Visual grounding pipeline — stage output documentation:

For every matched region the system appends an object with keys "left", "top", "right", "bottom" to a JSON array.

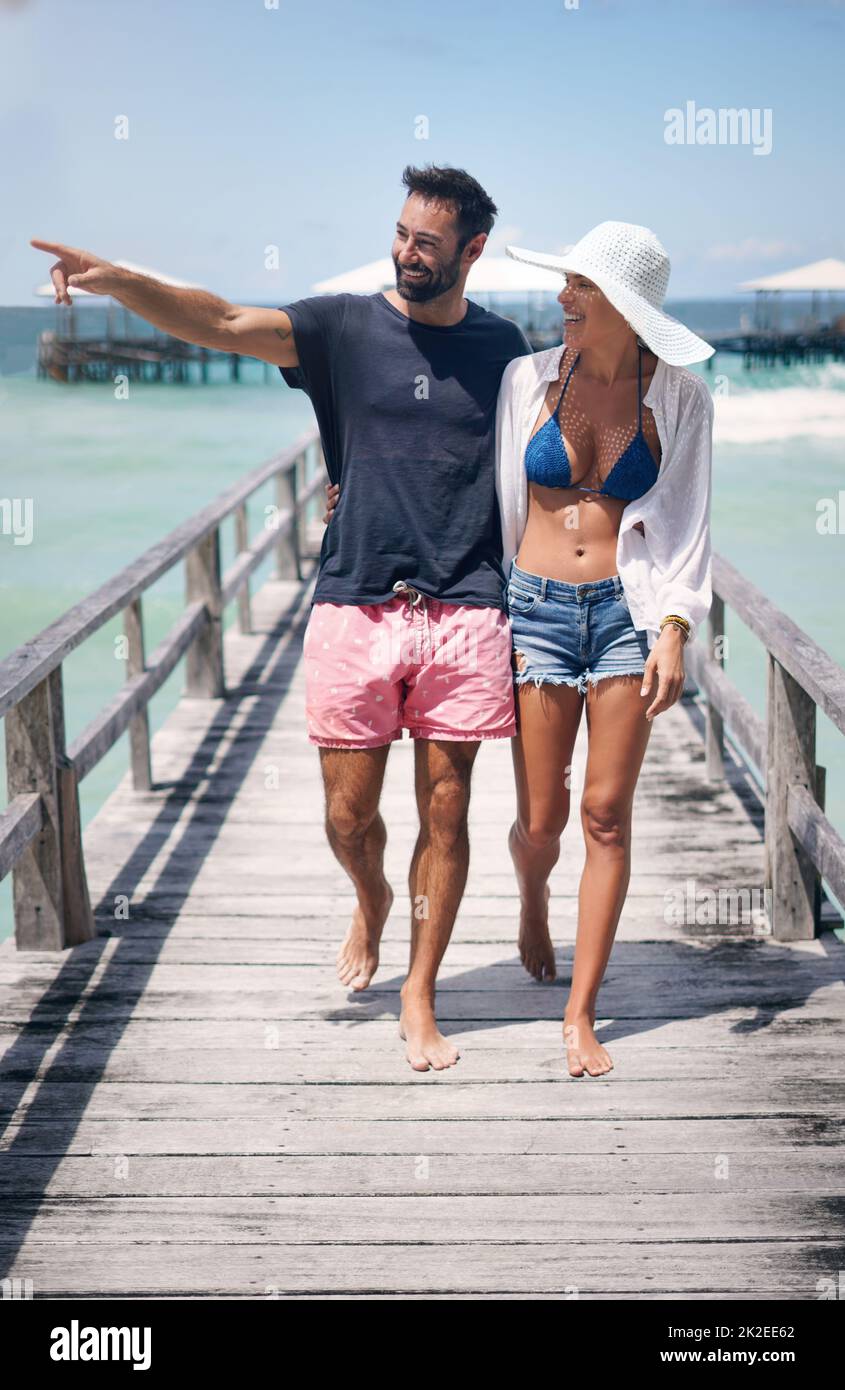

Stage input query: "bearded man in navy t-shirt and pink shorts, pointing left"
[{"left": 32, "top": 167, "right": 531, "bottom": 1072}]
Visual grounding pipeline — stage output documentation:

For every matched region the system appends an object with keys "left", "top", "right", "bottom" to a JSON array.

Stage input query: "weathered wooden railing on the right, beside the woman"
[{"left": 685, "top": 555, "right": 845, "bottom": 941}]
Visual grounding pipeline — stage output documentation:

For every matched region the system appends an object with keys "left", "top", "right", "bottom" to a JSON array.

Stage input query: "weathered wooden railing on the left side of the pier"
[{"left": 0, "top": 431, "right": 325, "bottom": 951}]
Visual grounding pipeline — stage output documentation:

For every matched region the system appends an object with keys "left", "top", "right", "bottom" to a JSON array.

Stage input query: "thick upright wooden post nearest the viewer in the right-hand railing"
[{"left": 764, "top": 653, "right": 817, "bottom": 941}]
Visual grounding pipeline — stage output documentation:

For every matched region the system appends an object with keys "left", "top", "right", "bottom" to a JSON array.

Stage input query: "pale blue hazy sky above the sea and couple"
[{"left": 0, "top": 0, "right": 845, "bottom": 304}]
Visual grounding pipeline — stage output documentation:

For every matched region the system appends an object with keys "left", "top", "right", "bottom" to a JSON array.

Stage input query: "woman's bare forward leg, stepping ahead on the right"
[{"left": 563, "top": 676, "right": 652, "bottom": 1076}]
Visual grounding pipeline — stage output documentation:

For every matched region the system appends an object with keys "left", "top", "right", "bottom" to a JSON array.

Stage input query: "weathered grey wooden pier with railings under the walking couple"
[{"left": 0, "top": 442, "right": 845, "bottom": 1300}]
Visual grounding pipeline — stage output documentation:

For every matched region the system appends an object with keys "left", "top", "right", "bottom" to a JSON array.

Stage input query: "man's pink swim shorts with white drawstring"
[{"left": 303, "top": 588, "right": 516, "bottom": 748}]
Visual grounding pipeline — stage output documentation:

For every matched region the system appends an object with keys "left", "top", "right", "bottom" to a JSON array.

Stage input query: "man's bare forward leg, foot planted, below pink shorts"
[{"left": 399, "top": 738, "right": 478, "bottom": 1072}]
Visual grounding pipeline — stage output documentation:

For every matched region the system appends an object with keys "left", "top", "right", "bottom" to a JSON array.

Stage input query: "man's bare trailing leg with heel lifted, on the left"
[{"left": 320, "top": 744, "right": 393, "bottom": 990}]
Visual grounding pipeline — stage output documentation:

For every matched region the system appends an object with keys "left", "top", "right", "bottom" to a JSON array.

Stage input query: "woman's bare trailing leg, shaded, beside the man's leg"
[{"left": 507, "top": 682, "right": 584, "bottom": 980}]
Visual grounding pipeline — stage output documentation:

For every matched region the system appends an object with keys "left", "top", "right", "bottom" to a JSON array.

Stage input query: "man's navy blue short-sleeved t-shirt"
[{"left": 279, "top": 293, "right": 531, "bottom": 609}]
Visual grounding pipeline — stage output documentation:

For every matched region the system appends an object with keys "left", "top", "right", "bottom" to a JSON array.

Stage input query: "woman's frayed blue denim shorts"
[{"left": 507, "top": 562, "right": 649, "bottom": 694}]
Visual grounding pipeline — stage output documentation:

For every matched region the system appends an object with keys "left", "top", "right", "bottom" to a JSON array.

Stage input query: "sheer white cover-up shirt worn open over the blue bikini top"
[{"left": 496, "top": 346, "right": 713, "bottom": 648}]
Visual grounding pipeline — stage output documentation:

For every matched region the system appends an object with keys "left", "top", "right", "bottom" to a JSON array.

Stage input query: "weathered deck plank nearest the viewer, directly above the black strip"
[{"left": 0, "top": 1240, "right": 845, "bottom": 1300}]
